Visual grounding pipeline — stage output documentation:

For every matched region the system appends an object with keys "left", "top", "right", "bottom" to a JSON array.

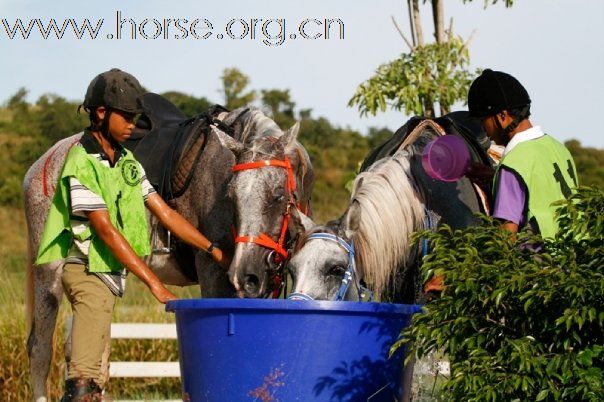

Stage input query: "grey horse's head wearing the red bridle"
[{"left": 217, "top": 110, "right": 313, "bottom": 297}]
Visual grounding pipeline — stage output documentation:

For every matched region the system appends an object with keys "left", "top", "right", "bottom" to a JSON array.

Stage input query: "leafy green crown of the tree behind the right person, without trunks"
[{"left": 348, "top": 35, "right": 473, "bottom": 116}]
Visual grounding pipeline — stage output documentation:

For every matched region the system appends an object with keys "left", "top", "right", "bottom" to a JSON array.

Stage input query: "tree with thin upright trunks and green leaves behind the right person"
[{"left": 348, "top": 0, "right": 513, "bottom": 117}]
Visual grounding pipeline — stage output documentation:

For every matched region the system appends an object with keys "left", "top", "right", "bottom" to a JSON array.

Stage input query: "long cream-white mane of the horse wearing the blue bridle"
[{"left": 349, "top": 149, "right": 425, "bottom": 295}]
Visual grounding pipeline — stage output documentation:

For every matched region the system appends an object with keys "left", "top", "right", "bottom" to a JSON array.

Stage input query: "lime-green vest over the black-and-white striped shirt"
[{"left": 36, "top": 145, "right": 151, "bottom": 272}]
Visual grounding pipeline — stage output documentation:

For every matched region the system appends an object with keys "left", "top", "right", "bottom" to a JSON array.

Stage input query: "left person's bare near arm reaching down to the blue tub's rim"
[{"left": 85, "top": 209, "right": 176, "bottom": 303}]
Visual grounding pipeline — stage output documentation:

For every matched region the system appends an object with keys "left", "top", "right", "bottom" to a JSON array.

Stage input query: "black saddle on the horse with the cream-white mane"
[{"left": 361, "top": 111, "right": 491, "bottom": 172}]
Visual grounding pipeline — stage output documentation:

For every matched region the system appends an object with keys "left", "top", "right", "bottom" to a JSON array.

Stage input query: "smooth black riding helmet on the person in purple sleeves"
[{"left": 468, "top": 69, "right": 531, "bottom": 117}]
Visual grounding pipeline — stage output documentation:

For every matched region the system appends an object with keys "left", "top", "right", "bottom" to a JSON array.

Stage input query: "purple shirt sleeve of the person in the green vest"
[{"left": 493, "top": 169, "right": 526, "bottom": 226}]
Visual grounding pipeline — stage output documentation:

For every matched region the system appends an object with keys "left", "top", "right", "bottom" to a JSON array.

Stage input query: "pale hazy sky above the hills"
[{"left": 0, "top": 0, "right": 604, "bottom": 148}]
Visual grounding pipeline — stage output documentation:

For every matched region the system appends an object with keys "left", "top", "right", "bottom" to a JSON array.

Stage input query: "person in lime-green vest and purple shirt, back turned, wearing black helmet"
[{"left": 467, "top": 69, "right": 578, "bottom": 238}]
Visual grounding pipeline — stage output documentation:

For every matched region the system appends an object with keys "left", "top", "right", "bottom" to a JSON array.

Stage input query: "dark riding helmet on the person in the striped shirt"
[{"left": 82, "top": 68, "right": 145, "bottom": 113}]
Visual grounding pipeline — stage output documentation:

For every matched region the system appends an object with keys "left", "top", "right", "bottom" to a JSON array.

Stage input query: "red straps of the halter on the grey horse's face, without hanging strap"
[{"left": 233, "top": 156, "right": 296, "bottom": 263}]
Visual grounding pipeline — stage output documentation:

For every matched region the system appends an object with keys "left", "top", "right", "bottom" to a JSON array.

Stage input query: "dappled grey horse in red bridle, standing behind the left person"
[{"left": 23, "top": 108, "right": 313, "bottom": 402}]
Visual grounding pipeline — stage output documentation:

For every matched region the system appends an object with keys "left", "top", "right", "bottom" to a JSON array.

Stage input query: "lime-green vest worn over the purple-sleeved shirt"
[{"left": 493, "top": 135, "right": 578, "bottom": 238}]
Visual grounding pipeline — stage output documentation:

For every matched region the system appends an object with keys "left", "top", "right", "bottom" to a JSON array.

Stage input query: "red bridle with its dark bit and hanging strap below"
[{"left": 232, "top": 156, "right": 297, "bottom": 297}]
